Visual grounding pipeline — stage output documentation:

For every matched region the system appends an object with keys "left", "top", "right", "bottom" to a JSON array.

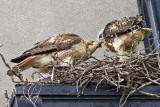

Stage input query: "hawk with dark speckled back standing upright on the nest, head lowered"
[{"left": 98, "top": 15, "right": 151, "bottom": 62}]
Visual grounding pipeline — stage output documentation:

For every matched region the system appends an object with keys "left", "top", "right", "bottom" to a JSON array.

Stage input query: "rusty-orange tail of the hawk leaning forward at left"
[{"left": 7, "top": 56, "right": 35, "bottom": 77}]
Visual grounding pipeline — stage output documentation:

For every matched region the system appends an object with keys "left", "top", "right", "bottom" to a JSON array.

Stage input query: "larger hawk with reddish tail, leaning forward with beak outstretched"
[{"left": 7, "top": 34, "right": 101, "bottom": 76}]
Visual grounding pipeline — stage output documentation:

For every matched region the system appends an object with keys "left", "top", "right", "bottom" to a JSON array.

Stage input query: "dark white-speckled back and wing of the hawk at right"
[{"left": 103, "top": 15, "right": 144, "bottom": 39}]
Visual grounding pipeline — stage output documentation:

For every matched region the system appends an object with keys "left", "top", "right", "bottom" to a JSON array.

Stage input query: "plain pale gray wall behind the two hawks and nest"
[{"left": 0, "top": 0, "right": 140, "bottom": 107}]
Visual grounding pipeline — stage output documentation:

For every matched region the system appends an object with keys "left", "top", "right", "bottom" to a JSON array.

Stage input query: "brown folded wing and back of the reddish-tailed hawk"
[{"left": 11, "top": 34, "right": 82, "bottom": 63}]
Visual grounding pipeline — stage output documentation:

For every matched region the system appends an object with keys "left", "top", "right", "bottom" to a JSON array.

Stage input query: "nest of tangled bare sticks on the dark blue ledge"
[{"left": 39, "top": 53, "right": 160, "bottom": 89}]
